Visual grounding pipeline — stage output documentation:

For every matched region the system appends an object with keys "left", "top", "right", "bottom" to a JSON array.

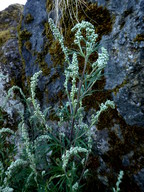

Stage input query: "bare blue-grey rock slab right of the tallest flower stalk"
[{"left": 97, "top": 0, "right": 144, "bottom": 127}]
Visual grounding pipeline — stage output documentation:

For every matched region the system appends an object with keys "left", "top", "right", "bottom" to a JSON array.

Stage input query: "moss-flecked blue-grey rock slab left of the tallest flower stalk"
[{"left": 20, "top": 0, "right": 64, "bottom": 110}]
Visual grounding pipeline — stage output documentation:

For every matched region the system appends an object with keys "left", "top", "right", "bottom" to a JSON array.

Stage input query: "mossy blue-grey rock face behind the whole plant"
[{"left": 0, "top": 0, "right": 144, "bottom": 192}]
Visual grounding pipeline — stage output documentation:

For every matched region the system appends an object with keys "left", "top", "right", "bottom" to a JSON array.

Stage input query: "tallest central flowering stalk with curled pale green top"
[{"left": 49, "top": 19, "right": 115, "bottom": 191}]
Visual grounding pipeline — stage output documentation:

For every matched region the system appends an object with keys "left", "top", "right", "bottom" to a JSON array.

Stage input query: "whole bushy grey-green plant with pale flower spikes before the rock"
[{"left": 0, "top": 19, "right": 115, "bottom": 192}]
